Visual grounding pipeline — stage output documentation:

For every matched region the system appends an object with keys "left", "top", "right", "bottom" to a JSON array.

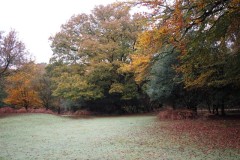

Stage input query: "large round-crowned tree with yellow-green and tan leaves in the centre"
[{"left": 50, "top": 3, "right": 144, "bottom": 110}]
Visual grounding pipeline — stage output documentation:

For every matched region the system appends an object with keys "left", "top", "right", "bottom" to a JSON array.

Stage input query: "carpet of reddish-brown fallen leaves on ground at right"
[{"left": 162, "top": 120, "right": 240, "bottom": 151}]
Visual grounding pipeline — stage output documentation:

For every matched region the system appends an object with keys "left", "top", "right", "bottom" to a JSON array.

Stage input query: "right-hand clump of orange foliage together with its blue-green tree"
[{"left": 125, "top": 0, "right": 240, "bottom": 115}]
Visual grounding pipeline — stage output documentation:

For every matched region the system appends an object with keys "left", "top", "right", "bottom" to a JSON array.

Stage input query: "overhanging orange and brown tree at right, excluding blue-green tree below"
[{"left": 129, "top": 0, "right": 240, "bottom": 114}]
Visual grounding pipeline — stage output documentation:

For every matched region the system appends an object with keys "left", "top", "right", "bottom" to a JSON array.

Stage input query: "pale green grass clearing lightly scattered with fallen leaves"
[{"left": 0, "top": 114, "right": 240, "bottom": 160}]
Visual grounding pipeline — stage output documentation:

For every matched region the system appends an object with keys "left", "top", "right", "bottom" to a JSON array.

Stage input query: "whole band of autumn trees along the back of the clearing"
[{"left": 0, "top": 0, "right": 240, "bottom": 115}]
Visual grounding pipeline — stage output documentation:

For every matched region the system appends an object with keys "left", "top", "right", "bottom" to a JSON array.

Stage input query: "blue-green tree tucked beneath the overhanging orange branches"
[{"left": 146, "top": 47, "right": 180, "bottom": 107}]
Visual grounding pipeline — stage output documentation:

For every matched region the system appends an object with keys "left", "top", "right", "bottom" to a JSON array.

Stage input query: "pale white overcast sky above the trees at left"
[{"left": 0, "top": 0, "right": 122, "bottom": 63}]
